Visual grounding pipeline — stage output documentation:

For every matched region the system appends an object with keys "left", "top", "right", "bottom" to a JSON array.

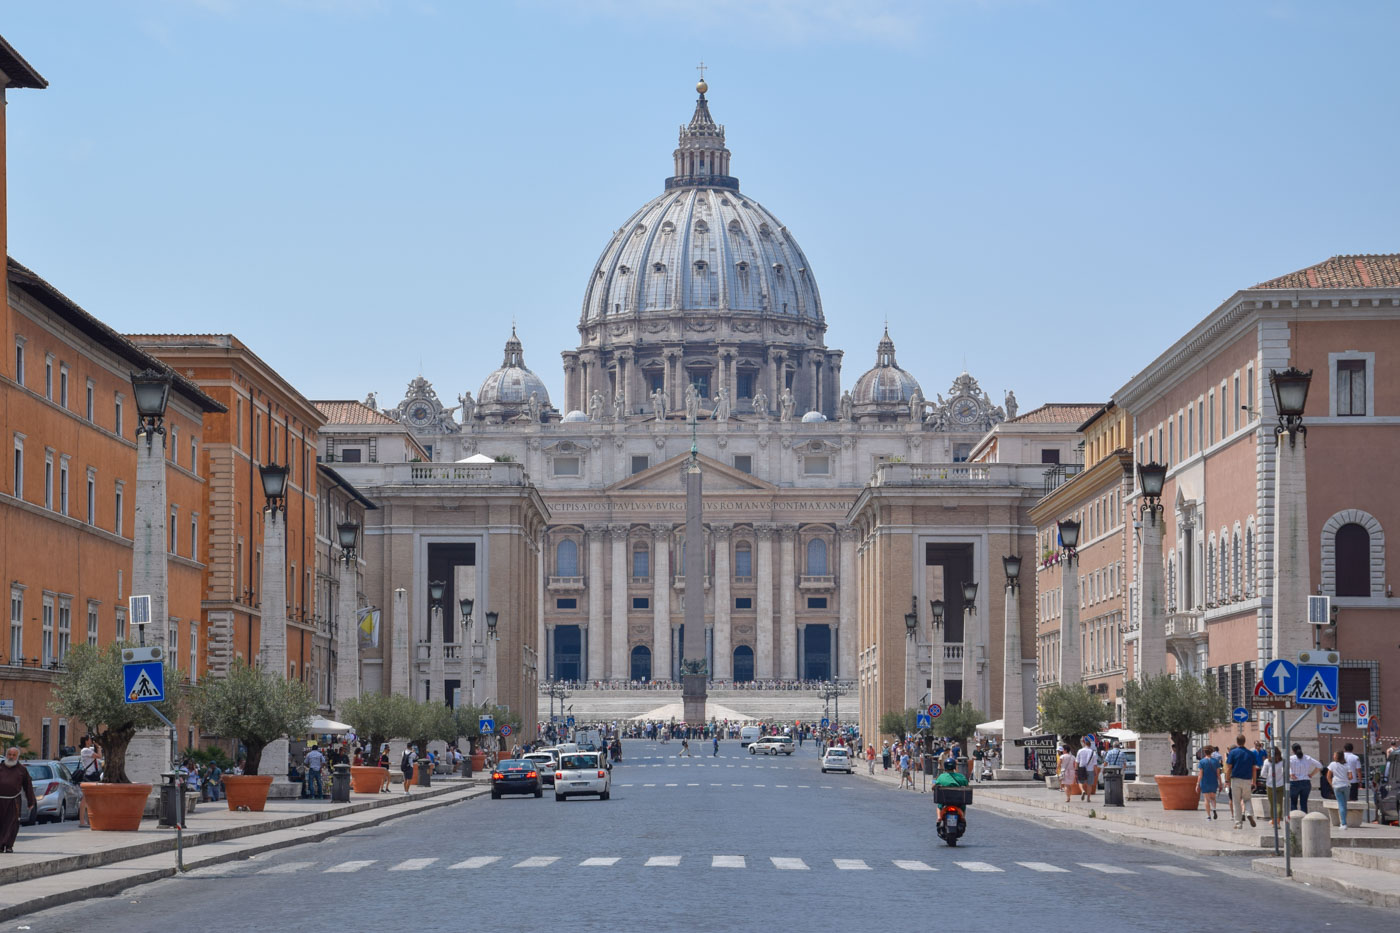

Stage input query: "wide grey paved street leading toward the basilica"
[{"left": 21, "top": 740, "right": 1389, "bottom": 933}]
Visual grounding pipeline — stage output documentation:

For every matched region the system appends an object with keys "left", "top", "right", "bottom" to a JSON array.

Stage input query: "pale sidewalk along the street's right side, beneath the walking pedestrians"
[{"left": 855, "top": 758, "right": 1400, "bottom": 906}]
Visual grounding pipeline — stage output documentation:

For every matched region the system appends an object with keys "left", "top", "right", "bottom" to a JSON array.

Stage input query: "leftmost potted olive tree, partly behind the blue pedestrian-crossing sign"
[{"left": 52, "top": 642, "right": 181, "bottom": 831}]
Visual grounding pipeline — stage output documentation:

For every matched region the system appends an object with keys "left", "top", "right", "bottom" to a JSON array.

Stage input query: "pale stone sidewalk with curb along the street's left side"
[{"left": 0, "top": 778, "right": 490, "bottom": 920}]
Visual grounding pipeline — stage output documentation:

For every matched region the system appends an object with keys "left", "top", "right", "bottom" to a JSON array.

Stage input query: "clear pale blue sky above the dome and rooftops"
[{"left": 0, "top": 0, "right": 1400, "bottom": 410}]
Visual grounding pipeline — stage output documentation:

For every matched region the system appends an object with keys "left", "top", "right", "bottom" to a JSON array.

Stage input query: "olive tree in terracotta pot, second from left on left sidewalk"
[{"left": 192, "top": 661, "right": 316, "bottom": 811}]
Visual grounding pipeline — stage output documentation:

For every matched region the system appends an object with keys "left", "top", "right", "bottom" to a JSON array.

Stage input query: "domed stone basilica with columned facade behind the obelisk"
[{"left": 340, "top": 83, "right": 1016, "bottom": 681}]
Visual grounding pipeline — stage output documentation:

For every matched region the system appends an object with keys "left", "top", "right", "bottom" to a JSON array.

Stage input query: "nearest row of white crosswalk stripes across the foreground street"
[{"left": 221, "top": 850, "right": 1204, "bottom": 878}]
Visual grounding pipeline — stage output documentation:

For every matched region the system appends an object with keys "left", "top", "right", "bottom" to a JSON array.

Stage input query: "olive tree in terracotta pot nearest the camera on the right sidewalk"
[{"left": 1123, "top": 674, "right": 1231, "bottom": 810}]
